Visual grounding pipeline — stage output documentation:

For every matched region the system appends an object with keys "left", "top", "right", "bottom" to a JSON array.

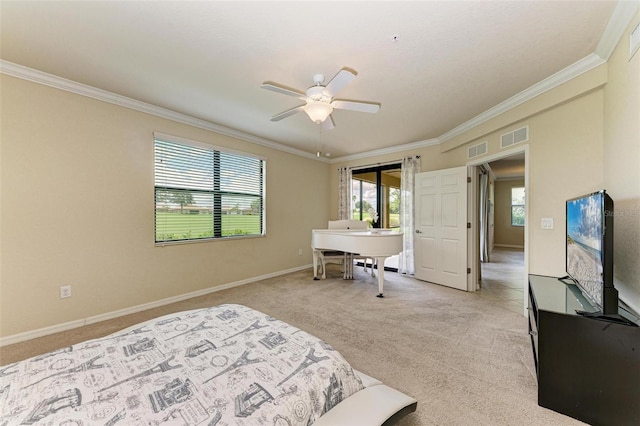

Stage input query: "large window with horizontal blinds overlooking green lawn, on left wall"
[{"left": 155, "top": 134, "right": 266, "bottom": 243}]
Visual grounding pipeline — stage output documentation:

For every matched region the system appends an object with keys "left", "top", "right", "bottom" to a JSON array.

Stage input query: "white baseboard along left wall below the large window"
[{"left": 0, "top": 265, "right": 312, "bottom": 347}]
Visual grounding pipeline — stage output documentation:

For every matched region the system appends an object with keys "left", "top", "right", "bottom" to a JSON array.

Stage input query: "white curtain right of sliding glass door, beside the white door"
[{"left": 398, "top": 156, "right": 420, "bottom": 275}]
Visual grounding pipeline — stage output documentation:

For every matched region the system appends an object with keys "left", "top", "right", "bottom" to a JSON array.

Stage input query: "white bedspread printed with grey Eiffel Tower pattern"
[{"left": 0, "top": 305, "right": 362, "bottom": 426}]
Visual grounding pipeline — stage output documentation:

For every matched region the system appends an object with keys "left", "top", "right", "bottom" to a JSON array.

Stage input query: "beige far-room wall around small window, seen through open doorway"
[{"left": 493, "top": 179, "right": 524, "bottom": 247}]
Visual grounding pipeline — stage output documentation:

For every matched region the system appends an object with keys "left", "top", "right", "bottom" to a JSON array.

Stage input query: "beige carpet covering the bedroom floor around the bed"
[{"left": 0, "top": 265, "right": 582, "bottom": 426}]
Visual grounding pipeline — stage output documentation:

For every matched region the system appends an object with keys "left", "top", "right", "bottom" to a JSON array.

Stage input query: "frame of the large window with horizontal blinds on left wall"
[{"left": 153, "top": 132, "right": 267, "bottom": 246}]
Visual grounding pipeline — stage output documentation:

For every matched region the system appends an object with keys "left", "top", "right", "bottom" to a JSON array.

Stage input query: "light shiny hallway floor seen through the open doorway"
[{"left": 478, "top": 247, "right": 525, "bottom": 314}]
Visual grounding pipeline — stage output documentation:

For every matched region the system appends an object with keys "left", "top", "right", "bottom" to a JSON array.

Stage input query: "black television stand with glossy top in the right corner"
[{"left": 528, "top": 275, "right": 640, "bottom": 425}]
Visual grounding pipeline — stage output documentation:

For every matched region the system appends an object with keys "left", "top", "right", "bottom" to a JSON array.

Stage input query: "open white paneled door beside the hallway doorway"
[{"left": 414, "top": 166, "right": 468, "bottom": 290}]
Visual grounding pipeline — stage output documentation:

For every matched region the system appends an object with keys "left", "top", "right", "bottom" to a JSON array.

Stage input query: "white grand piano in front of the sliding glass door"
[{"left": 311, "top": 229, "right": 402, "bottom": 297}]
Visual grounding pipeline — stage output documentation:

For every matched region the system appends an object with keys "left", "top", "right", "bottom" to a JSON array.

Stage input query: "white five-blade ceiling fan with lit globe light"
[{"left": 260, "top": 67, "right": 380, "bottom": 130}]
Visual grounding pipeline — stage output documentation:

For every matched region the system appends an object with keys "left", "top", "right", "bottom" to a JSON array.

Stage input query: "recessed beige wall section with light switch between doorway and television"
[{"left": 516, "top": 90, "right": 603, "bottom": 276}]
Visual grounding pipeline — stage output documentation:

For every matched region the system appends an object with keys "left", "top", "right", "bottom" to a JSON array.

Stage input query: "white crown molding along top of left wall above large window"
[{"left": 0, "top": 60, "right": 320, "bottom": 162}]
